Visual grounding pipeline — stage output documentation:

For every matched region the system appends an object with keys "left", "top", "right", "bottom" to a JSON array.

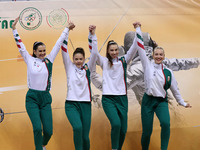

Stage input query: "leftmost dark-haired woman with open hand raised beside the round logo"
[{"left": 12, "top": 17, "right": 74, "bottom": 150}]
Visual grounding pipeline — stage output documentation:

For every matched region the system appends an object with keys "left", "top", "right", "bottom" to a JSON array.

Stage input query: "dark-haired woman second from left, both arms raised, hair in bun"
[{"left": 61, "top": 25, "right": 98, "bottom": 150}]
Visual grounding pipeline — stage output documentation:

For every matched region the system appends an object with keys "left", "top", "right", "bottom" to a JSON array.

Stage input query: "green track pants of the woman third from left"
[{"left": 102, "top": 95, "right": 128, "bottom": 150}]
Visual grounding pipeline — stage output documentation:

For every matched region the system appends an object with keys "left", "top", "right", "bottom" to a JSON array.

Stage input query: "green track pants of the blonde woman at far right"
[{"left": 141, "top": 94, "right": 170, "bottom": 150}]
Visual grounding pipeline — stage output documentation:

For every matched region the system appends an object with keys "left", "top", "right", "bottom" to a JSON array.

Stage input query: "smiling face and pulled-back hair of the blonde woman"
[{"left": 153, "top": 47, "right": 165, "bottom": 64}]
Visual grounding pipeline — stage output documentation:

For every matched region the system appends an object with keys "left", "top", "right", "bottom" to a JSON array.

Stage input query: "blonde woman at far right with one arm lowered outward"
[{"left": 134, "top": 23, "right": 191, "bottom": 150}]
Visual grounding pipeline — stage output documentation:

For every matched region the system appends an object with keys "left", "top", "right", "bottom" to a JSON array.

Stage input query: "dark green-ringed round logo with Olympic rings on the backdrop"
[{"left": 19, "top": 7, "right": 42, "bottom": 30}]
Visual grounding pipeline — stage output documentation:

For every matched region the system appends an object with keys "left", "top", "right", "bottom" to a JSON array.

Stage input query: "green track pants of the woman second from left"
[{"left": 65, "top": 101, "right": 91, "bottom": 150}]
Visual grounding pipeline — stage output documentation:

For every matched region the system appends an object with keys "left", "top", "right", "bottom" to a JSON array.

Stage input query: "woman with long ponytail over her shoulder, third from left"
[{"left": 92, "top": 22, "right": 137, "bottom": 150}]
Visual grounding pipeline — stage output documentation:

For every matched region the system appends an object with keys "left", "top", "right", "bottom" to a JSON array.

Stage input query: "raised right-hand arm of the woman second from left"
[{"left": 88, "top": 25, "right": 98, "bottom": 71}]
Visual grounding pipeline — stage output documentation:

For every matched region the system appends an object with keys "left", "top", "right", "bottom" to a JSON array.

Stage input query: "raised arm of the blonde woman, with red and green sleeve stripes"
[{"left": 133, "top": 22, "right": 150, "bottom": 70}]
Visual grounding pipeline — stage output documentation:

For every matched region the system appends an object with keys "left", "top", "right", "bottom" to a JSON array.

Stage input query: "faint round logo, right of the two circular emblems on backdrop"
[{"left": 46, "top": 8, "right": 69, "bottom": 29}]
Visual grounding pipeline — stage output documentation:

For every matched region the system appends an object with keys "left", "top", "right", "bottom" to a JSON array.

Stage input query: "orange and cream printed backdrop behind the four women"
[{"left": 0, "top": 0, "right": 200, "bottom": 150}]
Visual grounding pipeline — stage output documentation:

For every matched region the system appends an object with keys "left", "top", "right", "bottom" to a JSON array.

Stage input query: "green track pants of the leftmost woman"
[{"left": 26, "top": 89, "right": 53, "bottom": 150}]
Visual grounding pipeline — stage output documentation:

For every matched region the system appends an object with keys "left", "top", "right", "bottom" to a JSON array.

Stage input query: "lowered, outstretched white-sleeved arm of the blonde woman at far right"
[{"left": 170, "top": 71, "right": 191, "bottom": 108}]
